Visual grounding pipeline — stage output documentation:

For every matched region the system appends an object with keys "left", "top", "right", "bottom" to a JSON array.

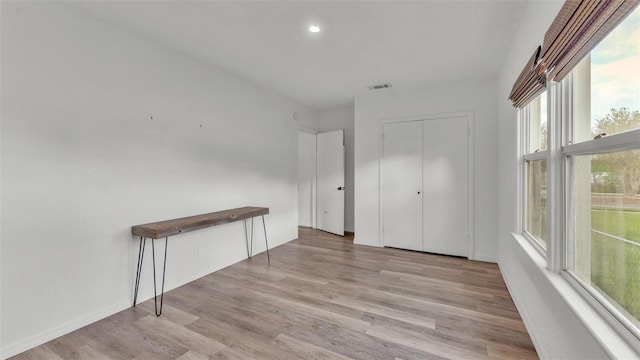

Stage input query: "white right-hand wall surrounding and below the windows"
[{"left": 497, "top": 1, "right": 637, "bottom": 359}]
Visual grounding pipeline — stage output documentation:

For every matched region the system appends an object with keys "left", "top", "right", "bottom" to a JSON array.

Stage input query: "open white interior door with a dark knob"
[{"left": 316, "top": 130, "right": 344, "bottom": 235}]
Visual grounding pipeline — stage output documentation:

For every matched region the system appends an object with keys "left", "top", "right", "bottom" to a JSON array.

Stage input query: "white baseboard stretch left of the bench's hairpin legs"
[{"left": 0, "top": 300, "right": 131, "bottom": 359}]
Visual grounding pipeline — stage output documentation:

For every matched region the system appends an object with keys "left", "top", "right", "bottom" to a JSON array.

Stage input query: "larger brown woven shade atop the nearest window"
[{"left": 540, "top": 0, "right": 640, "bottom": 81}]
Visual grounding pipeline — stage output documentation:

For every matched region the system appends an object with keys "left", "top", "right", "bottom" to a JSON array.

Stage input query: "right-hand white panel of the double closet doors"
[{"left": 422, "top": 116, "right": 469, "bottom": 257}]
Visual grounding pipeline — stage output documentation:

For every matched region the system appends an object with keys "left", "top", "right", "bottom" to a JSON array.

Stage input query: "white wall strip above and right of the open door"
[{"left": 318, "top": 106, "right": 354, "bottom": 231}]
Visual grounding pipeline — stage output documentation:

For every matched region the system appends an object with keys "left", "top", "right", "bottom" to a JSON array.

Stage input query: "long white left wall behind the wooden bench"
[{"left": 0, "top": 2, "right": 317, "bottom": 356}]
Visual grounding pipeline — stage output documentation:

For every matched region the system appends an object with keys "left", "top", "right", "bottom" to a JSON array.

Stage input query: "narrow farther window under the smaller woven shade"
[{"left": 523, "top": 91, "right": 547, "bottom": 250}]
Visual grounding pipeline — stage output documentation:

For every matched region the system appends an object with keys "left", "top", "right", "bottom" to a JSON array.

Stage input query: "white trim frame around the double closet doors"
[{"left": 378, "top": 111, "right": 476, "bottom": 260}]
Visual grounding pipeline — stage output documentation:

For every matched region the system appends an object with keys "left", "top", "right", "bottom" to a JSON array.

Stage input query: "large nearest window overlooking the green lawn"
[{"left": 563, "top": 8, "right": 640, "bottom": 333}]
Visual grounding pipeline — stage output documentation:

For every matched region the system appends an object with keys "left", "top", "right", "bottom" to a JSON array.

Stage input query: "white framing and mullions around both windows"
[{"left": 517, "top": 63, "right": 640, "bottom": 352}]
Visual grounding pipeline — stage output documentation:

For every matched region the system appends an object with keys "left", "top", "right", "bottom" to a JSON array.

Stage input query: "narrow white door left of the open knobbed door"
[{"left": 298, "top": 131, "right": 316, "bottom": 227}]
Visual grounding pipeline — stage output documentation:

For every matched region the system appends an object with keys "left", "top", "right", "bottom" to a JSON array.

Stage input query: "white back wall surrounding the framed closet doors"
[{"left": 354, "top": 79, "right": 498, "bottom": 261}]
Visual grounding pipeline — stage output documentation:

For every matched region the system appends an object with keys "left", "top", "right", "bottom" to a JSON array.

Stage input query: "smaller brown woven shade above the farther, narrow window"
[{"left": 509, "top": 46, "right": 547, "bottom": 107}]
